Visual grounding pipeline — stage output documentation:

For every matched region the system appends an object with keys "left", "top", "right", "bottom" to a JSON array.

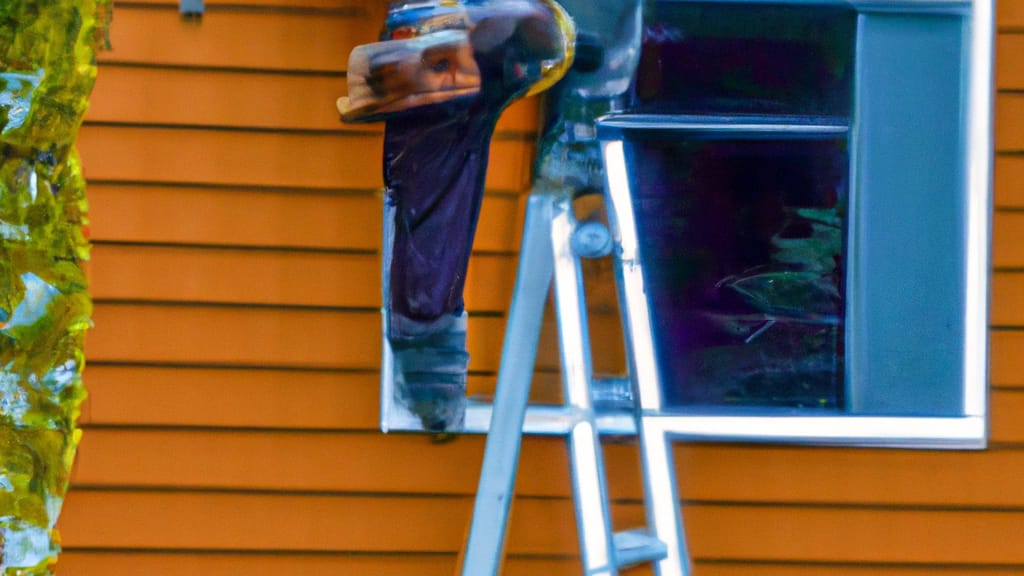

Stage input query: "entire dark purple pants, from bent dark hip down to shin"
[{"left": 384, "top": 11, "right": 559, "bottom": 341}]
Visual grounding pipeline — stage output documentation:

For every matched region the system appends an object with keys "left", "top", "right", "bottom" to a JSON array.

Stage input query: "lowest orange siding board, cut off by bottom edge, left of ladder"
[{"left": 57, "top": 549, "right": 585, "bottom": 576}]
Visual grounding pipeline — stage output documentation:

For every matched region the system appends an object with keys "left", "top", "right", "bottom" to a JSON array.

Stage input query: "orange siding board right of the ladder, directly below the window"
[{"left": 676, "top": 445, "right": 1024, "bottom": 508}]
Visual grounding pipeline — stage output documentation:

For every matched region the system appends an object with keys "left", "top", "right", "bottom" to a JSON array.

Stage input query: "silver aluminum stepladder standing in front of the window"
[{"left": 459, "top": 192, "right": 690, "bottom": 576}]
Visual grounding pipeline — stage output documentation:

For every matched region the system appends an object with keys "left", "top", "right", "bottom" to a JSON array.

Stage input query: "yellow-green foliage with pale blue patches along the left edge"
[{"left": 0, "top": 0, "right": 111, "bottom": 576}]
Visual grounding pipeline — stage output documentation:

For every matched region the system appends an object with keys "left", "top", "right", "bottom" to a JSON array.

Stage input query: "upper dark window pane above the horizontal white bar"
[{"left": 636, "top": 0, "right": 856, "bottom": 117}]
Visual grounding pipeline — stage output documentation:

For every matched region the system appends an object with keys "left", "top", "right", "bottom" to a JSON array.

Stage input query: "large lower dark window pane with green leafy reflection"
[{"left": 627, "top": 138, "right": 848, "bottom": 409}]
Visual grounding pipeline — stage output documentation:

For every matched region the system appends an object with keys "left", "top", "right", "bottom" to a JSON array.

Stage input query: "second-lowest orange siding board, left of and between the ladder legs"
[{"left": 58, "top": 485, "right": 593, "bottom": 554}]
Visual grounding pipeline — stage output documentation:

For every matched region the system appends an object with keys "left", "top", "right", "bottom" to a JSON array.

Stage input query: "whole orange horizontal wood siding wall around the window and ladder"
[{"left": 58, "top": 0, "right": 1024, "bottom": 576}]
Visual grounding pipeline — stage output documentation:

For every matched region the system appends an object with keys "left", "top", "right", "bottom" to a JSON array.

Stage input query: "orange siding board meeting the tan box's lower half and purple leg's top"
[{"left": 86, "top": 64, "right": 538, "bottom": 132}]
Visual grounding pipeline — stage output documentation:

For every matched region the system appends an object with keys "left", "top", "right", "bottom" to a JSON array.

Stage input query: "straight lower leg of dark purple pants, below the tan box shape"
[{"left": 384, "top": 101, "right": 497, "bottom": 340}]
